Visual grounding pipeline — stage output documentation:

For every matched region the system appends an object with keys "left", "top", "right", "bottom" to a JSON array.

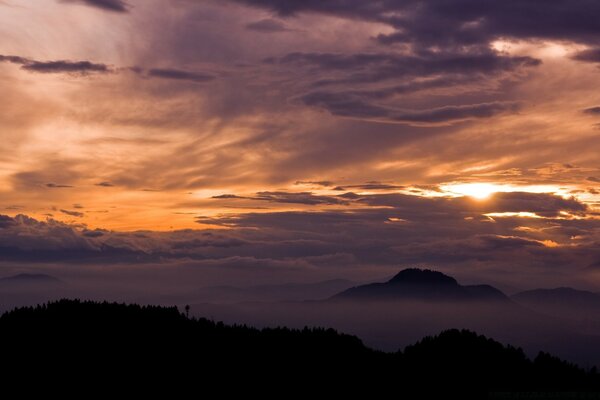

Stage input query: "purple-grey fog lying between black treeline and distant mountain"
[{"left": 0, "top": 275, "right": 600, "bottom": 367}]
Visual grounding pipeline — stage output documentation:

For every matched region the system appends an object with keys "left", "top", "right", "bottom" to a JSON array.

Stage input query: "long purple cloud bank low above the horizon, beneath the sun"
[{"left": 0, "top": 183, "right": 600, "bottom": 290}]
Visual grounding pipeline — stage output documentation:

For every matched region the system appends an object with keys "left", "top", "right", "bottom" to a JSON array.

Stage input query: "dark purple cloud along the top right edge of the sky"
[{"left": 232, "top": 0, "right": 600, "bottom": 48}]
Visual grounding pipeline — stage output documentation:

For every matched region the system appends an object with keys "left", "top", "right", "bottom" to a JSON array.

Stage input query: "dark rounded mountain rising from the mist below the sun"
[{"left": 332, "top": 268, "right": 509, "bottom": 301}]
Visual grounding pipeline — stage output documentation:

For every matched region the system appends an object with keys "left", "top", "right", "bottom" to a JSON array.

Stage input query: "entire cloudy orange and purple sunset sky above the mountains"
[{"left": 0, "top": 0, "right": 600, "bottom": 290}]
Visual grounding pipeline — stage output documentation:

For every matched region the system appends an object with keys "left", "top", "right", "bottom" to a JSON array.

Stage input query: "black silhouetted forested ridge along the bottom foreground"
[{"left": 0, "top": 300, "right": 600, "bottom": 398}]
